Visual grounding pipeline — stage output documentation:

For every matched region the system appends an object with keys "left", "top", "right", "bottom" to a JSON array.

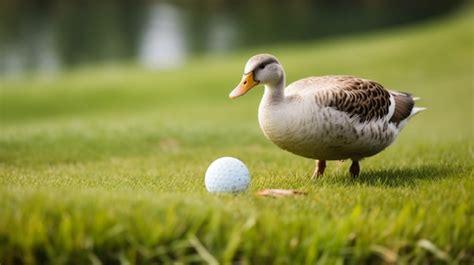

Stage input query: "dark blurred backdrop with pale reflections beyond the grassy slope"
[{"left": 0, "top": 0, "right": 462, "bottom": 79}]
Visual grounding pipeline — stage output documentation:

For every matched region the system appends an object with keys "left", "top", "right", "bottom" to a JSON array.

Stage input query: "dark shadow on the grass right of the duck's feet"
[{"left": 352, "top": 165, "right": 463, "bottom": 187}]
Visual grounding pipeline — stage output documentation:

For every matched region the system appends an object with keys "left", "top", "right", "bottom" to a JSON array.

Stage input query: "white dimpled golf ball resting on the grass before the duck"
[{"left": 204, "top": 157, "right": 250, "bottom": 193}]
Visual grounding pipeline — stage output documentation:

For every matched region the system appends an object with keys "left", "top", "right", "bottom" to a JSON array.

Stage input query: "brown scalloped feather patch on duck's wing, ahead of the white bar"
[{"left": 328, "top": 76, "right": 390, "bottom": 122}]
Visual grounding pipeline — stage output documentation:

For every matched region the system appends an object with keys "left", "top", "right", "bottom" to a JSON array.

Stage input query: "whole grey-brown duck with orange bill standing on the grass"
[{"left": 229, "top": 54, "right": 426, "bottom": 178}]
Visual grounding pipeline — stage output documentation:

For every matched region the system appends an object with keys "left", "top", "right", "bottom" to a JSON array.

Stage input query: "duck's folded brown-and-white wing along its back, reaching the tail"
[{"left": 292, "top": 76, "right": 423, "bottom": 125}]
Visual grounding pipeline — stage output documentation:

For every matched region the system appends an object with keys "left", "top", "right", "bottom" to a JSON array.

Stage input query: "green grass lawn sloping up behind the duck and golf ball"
[{"left": 0, "top": 8, "right": 474, "bottom": 264}]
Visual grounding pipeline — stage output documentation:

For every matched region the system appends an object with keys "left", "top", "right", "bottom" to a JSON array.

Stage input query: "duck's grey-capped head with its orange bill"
[{"left": 229, "top": 54, "right": 284, "bottom": 98}]
